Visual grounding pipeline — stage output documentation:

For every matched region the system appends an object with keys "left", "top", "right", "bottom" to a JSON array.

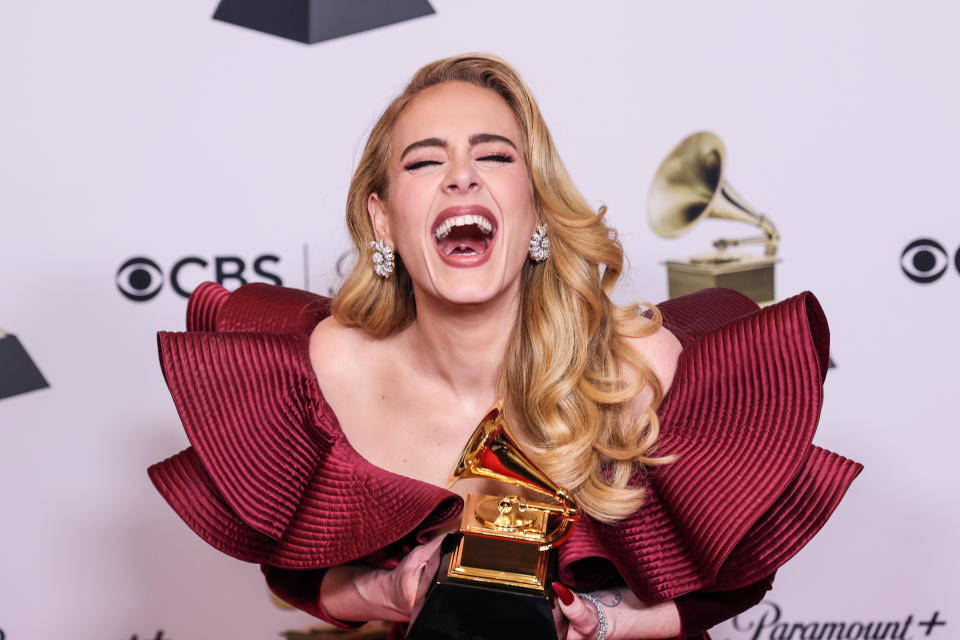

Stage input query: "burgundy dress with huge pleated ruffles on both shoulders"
[{"left": 149, "top": 283, "right": 862, "bottom": 638}]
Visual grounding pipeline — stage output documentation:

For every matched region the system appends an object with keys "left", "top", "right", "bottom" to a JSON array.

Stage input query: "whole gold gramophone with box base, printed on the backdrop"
[{"left": 647, "top": 131, "right": 780, "bottom": 305}]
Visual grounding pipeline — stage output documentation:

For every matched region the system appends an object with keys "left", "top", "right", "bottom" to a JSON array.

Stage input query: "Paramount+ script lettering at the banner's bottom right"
[{"left": 725, "top": 600, "right": 947, "bottom": 640}]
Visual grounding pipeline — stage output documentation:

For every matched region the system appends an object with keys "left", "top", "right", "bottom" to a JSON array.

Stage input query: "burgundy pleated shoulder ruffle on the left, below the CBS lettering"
[{"left": 149, "top": 285, "right": 462, "bottom": 569}]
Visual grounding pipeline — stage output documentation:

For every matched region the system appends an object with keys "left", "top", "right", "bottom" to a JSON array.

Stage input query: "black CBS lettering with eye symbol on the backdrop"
[{"left": 116, "top": 253, "right": 283, "bottom": 302}]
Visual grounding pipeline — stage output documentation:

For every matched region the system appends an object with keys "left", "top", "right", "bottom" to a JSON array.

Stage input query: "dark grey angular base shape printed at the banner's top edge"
[{"left": 213, "top": 0, "right": 436, "bottom": 44}]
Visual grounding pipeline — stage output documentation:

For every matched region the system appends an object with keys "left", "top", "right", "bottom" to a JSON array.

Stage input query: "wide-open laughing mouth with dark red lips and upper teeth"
[{"left": 433, "top": 206, "right": 497, "bottom": 267}]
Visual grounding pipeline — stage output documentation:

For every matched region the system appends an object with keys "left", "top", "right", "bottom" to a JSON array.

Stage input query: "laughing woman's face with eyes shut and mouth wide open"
[{"left": 368, "top": 82, "right": 537, "bottom": 304}]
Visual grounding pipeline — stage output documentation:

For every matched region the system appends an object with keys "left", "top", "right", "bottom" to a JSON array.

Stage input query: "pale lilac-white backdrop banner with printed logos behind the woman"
[{"left": 0, "top": 0, "right": 960, "bottom": 640}]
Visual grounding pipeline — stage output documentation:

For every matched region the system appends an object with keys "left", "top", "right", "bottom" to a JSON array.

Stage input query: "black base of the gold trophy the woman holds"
[{"left": 407, "top": 535, "right": 557, "bottom": 640}]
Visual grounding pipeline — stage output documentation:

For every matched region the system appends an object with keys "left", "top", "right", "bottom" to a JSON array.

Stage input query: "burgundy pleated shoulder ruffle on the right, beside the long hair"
[{"left": 560, "top": 290, "right": 861, "bottom": 602}]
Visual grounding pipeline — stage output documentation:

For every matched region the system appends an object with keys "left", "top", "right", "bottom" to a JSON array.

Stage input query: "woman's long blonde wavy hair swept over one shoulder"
[{"left": 332, "top": 54, "right": 669, "bottom": 522}]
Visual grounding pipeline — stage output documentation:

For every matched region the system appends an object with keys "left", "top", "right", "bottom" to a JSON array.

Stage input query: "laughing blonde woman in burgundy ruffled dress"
[{"left": 151, "top": 55, "right": 859, "bottom": 639}]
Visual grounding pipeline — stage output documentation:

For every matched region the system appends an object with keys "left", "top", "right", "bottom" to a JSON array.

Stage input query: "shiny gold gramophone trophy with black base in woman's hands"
[{"left": 407, "top": 409, "right": 579, "bottom": 640}]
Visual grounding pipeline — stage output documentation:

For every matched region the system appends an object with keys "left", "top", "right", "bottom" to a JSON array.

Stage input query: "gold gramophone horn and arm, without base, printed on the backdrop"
[{"left": 647, "top": 131, "right": 780, "bottom": 256}]
